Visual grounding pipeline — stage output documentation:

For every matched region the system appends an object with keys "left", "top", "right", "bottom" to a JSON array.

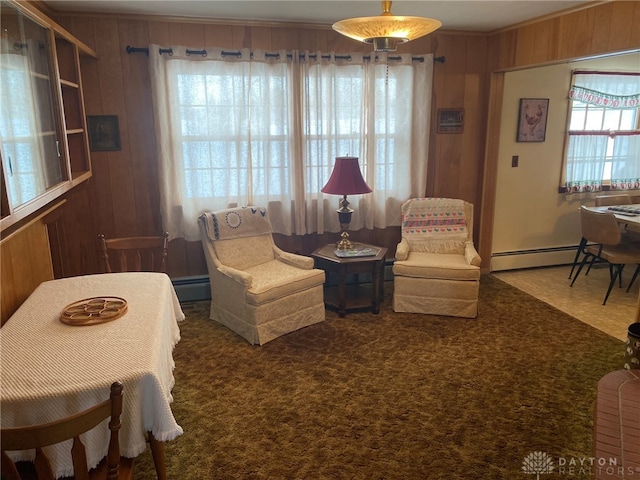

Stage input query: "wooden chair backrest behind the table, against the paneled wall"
[{"left": 98, "top": 232, "right": 169, "bottom": 273}]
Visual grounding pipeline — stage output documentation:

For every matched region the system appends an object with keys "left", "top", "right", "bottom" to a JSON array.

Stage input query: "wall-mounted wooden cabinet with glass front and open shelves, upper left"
[{"left": 0, "top": 0, "right": 97, "bottom": 235}]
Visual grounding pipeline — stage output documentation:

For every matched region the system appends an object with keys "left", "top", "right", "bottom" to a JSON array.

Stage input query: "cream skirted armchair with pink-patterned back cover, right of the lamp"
[{"left": 393, "top": 198, "right": 480, "bottom": 318}]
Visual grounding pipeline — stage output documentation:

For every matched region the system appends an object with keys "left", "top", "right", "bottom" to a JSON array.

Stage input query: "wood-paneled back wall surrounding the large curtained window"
[{"left": 46, "top": 12, "right": 487, "bottom": 277}]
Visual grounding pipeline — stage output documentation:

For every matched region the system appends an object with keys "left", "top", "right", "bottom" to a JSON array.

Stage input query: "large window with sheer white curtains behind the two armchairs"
[{"left": 150, "top": 45, "right": 433, "bottom": 240}]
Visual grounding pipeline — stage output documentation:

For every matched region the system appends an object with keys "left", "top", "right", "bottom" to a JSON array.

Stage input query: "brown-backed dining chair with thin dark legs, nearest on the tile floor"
[{"left": 571, "top": 205, "right": 640, "bottom": 305}]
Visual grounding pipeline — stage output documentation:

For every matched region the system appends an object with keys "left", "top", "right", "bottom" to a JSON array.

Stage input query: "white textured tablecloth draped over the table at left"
[{"left": 0, "top": 273, "right": 184, "bottom": 477}]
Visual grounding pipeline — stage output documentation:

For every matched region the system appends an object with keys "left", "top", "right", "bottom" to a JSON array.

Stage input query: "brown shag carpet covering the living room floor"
[{"left": 135, "top": 276, "right": 624, "bottom": 480}]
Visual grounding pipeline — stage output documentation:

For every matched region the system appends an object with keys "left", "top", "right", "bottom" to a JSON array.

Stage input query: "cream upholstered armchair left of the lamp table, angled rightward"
[{"left": 198, "top": 207, "right": 325, "bottom": 345}]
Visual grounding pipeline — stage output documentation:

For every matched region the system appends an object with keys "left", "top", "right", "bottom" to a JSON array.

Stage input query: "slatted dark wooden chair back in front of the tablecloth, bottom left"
[{"left": 0, "top": 382, "right": 123, "bottom": 480}]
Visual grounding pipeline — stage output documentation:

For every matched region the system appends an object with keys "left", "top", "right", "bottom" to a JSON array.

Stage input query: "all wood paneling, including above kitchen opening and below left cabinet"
[{"left": 2, "top": 1, "right": 640, "bottom": 319}]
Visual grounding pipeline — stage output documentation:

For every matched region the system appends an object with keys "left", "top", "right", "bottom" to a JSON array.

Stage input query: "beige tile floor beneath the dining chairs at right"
[{"left": 492, "top": 265, "right": 640, "bottom": 341}]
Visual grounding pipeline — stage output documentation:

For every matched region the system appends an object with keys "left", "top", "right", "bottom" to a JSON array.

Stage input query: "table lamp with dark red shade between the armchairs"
[{"left": 320, "top": 157, "right": 371, "bottom": 250}]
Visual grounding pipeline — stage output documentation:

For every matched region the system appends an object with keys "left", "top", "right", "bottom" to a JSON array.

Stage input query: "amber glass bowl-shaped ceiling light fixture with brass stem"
[{"left": 333, "top": 1, "right": 442, "bottom": 52}]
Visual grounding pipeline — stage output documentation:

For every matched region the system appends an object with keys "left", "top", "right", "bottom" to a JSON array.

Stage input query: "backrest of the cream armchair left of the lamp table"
[{"left": 198, "top": 207, "right": 275, "bottom": 270}]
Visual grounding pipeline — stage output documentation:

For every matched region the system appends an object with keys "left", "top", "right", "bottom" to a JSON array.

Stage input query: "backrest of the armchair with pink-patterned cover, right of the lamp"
[{"left": 401, "top": 198, "right": 473, "bottom": 253}]
